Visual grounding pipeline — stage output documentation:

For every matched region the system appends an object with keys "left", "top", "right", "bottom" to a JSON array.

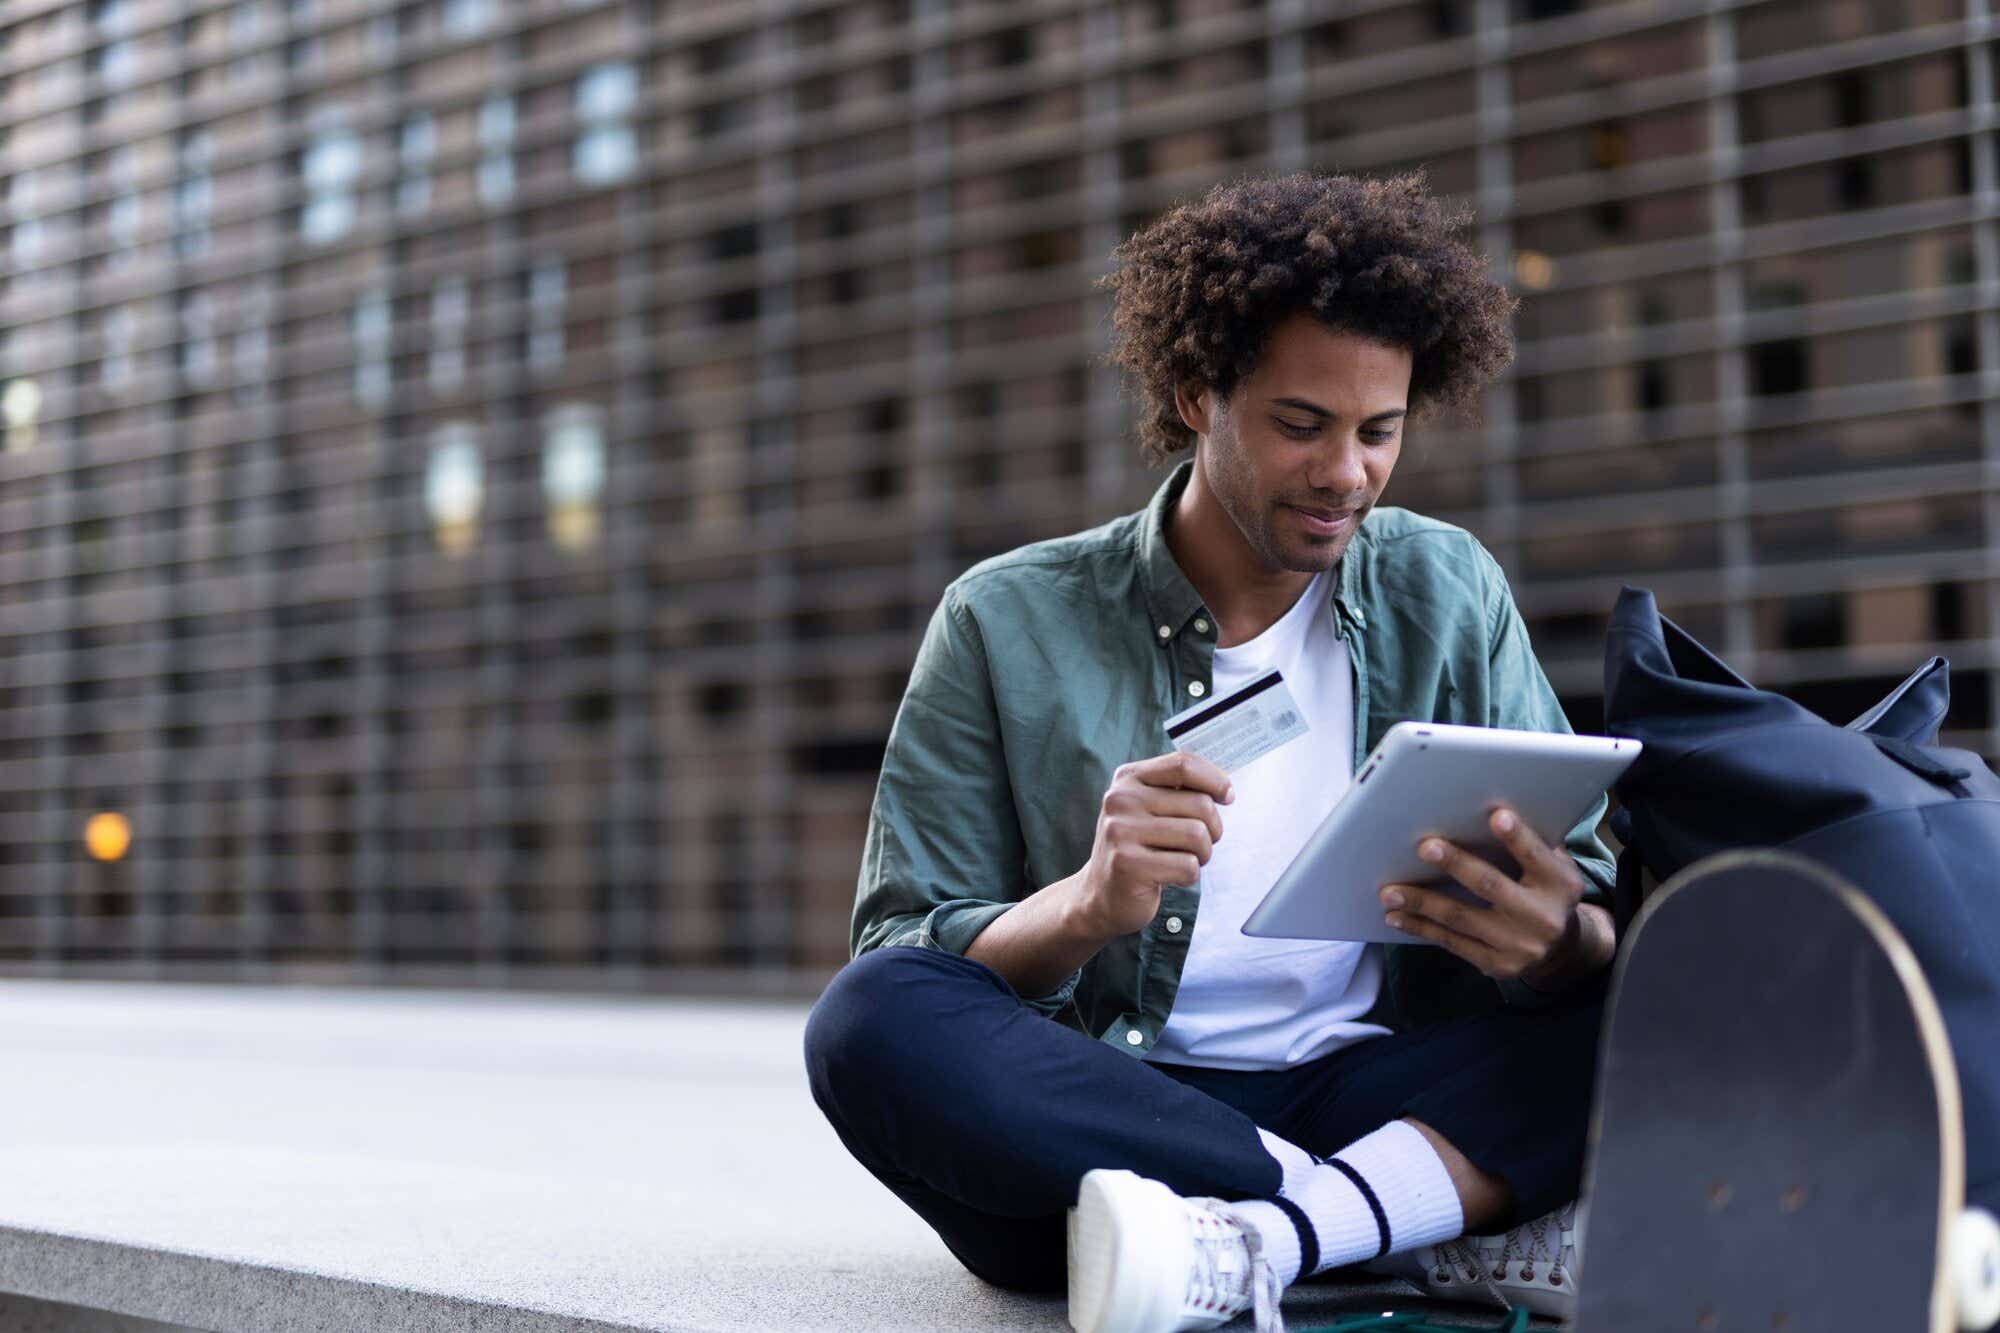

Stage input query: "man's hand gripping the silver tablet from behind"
[{"left": 1380, "top": 807, "right": 1614, "bottom": 989}]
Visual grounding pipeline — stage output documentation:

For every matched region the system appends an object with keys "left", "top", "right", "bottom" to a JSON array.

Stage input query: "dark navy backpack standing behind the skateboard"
[{"left": 1604, "top": 588, "right": 2000, "bottom": 1211}]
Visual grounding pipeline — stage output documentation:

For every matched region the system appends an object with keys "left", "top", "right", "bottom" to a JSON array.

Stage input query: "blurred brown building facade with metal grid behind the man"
[{"left": 0, "top": 0, "right": 2000, "bottom": 993}]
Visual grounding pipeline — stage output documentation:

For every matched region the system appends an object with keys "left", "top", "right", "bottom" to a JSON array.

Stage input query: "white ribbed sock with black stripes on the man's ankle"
[{"left": 1230, "top": 1121, "right": 1466, "bottom": 1285}]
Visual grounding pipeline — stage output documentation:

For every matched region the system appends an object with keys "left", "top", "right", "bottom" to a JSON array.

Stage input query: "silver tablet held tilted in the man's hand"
[{"left": 1244, "top": 723, "right": 1640, "bottom": 945}]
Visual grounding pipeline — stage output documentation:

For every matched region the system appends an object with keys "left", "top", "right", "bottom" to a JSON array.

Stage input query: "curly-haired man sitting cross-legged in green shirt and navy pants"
[{"left": 806, "top": 174, "right": 1614, "bottom": 1333}]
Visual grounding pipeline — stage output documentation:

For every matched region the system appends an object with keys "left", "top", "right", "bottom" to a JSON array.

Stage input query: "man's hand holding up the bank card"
[{"left": 1076, "top": 751, "right": 1234, "bottom": 939}]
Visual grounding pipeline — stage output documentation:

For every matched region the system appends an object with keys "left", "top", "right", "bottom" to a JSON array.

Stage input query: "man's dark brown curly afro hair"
[{"left": 1094, "top": 168, "right": 1520, "bottom": 464}]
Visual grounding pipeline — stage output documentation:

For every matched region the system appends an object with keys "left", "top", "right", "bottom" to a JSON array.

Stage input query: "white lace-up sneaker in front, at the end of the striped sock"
[{"left": 1070, "top": 1171, "right": 1284, "bottom": 1333}]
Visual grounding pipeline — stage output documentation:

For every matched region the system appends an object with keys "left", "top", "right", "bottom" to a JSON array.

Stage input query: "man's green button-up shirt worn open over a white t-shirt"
[{"left": 850, "top": 462, "right": 1614, "bottom": 1055}]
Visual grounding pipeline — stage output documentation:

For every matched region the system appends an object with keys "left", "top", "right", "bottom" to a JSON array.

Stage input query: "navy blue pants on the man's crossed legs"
[{"left": 806, "top": 947, "right": 1604, "bottom": 1291}]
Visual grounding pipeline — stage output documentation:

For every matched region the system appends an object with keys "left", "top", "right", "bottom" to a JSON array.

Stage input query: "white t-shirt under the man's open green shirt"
[{"left": 1148, "top": 572, "right": 1388, "bottom": 1069}]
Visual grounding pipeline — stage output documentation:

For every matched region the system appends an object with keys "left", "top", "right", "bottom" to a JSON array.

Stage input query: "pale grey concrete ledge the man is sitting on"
[{"left": 0, "top": 979, "right": 1536, "bottom": 1333}]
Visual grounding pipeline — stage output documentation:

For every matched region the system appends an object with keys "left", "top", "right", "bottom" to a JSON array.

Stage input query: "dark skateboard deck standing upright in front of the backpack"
[{"left": 1576, "top": 851, "right": 1964, "bottom": 1333}]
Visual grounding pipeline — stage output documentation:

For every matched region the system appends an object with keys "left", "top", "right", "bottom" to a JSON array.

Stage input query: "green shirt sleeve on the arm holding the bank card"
[{"left": 848, "top": 586, "right": 1082, "bottom": 1015}]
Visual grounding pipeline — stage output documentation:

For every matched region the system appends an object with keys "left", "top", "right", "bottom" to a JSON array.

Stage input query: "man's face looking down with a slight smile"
[{"left": 1180, "top": 314, "right": 1410, "bottom": 572}]
